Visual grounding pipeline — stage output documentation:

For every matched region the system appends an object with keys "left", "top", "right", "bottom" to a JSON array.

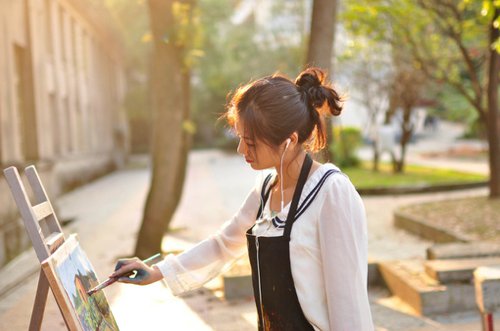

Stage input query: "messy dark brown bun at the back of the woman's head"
[{"left": 295, "top": 67, "right": 342, "bottom": 116}]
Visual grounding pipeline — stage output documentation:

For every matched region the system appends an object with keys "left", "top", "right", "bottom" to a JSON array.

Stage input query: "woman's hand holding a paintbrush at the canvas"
[{"left": 109, "top": 257, "right": 163, "bottom": 285}]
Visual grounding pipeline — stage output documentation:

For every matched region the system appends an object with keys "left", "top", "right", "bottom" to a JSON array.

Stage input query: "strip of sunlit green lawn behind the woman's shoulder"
[{"left": 342, "top": 162, "right": 488, "bottom": 188}]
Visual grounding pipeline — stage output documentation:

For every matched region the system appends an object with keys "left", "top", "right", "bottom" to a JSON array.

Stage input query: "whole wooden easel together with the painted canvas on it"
[{"left": 4, "top": 166, "right": 118, "bottom": 331}]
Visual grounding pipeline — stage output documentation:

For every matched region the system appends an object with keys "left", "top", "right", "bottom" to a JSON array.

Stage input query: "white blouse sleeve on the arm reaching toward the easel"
[{"left": 156, "top": 185, "right": 260, "bottom": 295}]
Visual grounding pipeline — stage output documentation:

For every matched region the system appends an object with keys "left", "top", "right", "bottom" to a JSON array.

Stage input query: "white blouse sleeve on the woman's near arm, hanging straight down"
[{"left": 319, "top": 174, "right": 373, "bottom": 331}]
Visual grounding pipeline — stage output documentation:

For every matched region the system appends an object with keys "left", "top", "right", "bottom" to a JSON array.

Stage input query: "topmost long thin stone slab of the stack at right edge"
[{"left": 427, "top": 241, "right": 500, "bottom": 260}]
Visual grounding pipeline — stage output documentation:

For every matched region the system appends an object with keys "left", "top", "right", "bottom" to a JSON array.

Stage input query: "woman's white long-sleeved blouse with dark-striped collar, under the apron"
[{"left": 157, "top": 163, "right": 373, "bottom": 331}]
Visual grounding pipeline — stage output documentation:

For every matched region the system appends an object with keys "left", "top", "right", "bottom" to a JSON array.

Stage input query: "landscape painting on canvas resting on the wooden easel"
[{"left": 42, "top": 235, "right": 119, "bottom": 331}]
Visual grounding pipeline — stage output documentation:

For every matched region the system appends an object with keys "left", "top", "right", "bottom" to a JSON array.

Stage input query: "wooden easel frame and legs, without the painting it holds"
[{"left": 4, "top": 166, "right": 68, "bottom": 331}]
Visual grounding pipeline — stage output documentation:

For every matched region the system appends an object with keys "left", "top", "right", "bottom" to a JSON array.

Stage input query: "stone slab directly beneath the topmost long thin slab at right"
[{"left": 424, "top": 257, "right": 500, "bottom": 284}]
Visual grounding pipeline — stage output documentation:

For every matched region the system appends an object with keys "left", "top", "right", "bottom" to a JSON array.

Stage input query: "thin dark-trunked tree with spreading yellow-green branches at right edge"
[{"left": 390, "top": 0, "right": 500, "bottom": 191}]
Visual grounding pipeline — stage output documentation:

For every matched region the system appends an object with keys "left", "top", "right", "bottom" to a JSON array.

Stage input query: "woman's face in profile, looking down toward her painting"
[{"left": 236, "top": 121, "right": 280, "bottom": 170}]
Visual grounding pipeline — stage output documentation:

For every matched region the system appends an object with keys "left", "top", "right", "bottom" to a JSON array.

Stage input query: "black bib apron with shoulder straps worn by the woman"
[{"left": 247, "top": 155, "right": 314, "bottom": 331}]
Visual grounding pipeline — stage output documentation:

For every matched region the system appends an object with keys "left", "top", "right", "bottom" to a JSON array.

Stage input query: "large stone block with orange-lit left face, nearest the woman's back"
[{"left": 379, "top": 260, "right": 476, "bottom": 316}]
